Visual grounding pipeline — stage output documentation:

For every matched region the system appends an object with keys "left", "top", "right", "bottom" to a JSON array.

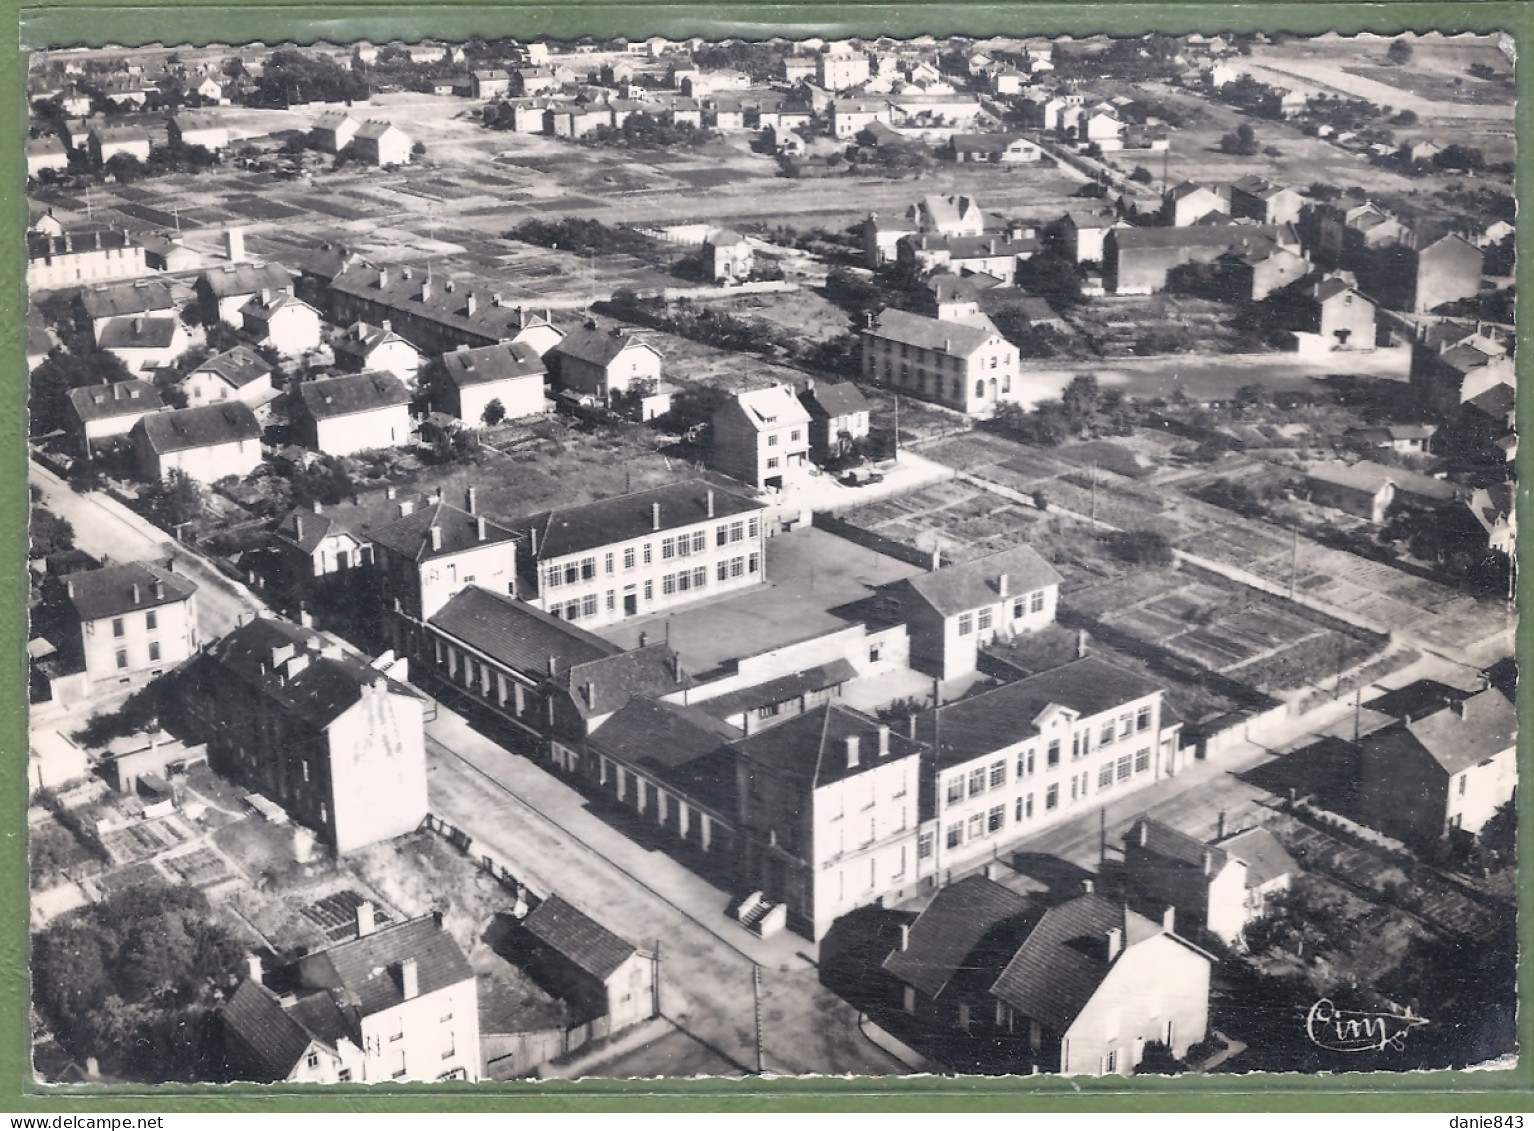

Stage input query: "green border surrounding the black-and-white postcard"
[{"left": 0, "top": 0, "right": 1534, "bottom": 1114}]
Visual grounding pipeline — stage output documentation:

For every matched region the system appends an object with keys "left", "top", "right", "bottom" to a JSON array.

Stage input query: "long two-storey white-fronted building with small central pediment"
[{"left": 913, "top": 657, "right": 1181, "bottom": 887}]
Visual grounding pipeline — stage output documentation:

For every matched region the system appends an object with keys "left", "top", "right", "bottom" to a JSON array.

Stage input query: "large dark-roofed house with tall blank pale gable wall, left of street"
[{"left": 178, "top": 617, "right": 426, "bottom": 853}]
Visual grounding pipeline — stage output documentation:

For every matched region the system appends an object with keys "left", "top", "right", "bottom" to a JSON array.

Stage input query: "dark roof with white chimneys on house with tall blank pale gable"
[{"left": 204, "top": 617, "right": 416, "bottom": 730}]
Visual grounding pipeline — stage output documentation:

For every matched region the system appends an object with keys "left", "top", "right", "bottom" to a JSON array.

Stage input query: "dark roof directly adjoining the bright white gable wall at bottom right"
[{"left": 991, "top": 895, "right": 1163, "bottom": 1033}]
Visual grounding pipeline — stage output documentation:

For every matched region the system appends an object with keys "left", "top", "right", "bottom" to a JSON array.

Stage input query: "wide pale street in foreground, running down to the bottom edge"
[{"left": 428, "top": 709, "right": 900, "bottom": 1076}]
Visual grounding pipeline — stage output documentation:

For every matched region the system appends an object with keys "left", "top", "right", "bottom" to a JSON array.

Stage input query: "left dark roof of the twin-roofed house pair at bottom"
[{"left": 884, "top": 876, "right": 1040, "bottom": 999}]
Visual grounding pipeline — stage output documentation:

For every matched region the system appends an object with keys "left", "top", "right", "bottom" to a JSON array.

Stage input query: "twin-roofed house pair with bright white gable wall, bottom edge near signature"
[{"left": 884, "top": 876, "right": 1213, "bottom": 1076}]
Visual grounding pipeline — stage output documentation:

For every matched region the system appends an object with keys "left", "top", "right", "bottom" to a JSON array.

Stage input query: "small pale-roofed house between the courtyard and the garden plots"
[{"left": 887, "top": 546, "right": 1060, "bottom": 680}]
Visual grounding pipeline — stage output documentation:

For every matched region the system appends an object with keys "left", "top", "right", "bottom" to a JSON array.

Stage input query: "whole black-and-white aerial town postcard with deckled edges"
[{"left": 25, "top": 26, "right": 1519, "bottom": 1086}]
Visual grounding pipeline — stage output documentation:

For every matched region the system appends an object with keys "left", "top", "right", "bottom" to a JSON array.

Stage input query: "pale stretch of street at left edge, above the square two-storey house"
[{"left": 28, "top": 460, "right": 265, "bottom": 640}]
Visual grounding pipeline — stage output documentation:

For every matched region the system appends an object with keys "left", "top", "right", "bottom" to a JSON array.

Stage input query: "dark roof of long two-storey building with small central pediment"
[{"left": 916, "top": 657, "right": 1166, "bottom": 770}]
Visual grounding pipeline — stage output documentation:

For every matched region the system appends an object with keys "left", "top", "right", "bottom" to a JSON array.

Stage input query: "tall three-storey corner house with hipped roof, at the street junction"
[{"left": 735, "top": 703, "right": 922, "bottom": 941}]
